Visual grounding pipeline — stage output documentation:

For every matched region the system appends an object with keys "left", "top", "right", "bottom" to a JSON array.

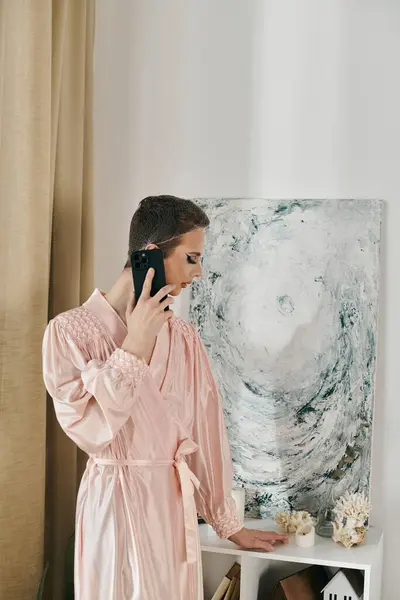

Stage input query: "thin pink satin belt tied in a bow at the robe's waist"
[{"left": 91, "top": 438, "right": 200, "bottom": 564}]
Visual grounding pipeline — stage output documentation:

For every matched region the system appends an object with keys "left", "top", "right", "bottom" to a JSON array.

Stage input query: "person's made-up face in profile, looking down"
[{"left": 164, "top": 229, "right": 204, "bottom": 296}]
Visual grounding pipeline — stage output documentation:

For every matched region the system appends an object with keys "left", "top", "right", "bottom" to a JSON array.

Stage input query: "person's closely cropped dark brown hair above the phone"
[{"left": 125, "top": 196, "right": 210, "bottom": 268}]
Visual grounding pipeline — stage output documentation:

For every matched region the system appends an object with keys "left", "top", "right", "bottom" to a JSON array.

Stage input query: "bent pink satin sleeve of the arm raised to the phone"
[{"left": 43, "top": 318, "right": 148, "bottom": 454}]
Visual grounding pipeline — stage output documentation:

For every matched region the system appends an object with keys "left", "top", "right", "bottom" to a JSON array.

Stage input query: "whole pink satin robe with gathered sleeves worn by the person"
[{"left": 43, "top": 290, "right": 242, "bottom": 600}]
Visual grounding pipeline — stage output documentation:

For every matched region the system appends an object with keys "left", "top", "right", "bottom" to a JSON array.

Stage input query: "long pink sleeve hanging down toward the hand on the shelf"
[{"left": 188, "top": 333, "right": 243, "bottom": 538}]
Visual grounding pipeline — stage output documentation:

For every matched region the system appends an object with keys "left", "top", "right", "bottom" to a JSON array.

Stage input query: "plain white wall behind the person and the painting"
[{"left": 95, "top": 0, "right": 400, "bottom": 600}]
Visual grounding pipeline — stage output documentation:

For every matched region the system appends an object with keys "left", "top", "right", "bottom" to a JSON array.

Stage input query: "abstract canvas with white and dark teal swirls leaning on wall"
[{"left": 190, "top": 199, "right": 382, "bottom": 517}]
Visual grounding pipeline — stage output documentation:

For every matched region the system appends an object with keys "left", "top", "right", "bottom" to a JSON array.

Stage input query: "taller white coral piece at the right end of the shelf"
[{"left": 332, "top": 492, "right": 371, "bottom": 548}]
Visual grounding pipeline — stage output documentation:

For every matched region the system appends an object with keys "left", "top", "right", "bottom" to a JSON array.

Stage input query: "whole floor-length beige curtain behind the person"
[{"left": 0, "top": 0, "right": 94, "bottom": 600}]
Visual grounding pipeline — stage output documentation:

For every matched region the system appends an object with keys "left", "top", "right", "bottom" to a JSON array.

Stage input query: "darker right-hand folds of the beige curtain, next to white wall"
[{"left": 46, "top": 0, "right": 94, "bottom": 598}]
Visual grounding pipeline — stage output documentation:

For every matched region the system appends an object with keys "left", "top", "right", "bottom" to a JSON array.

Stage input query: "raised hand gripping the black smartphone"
[{"left": 122, "top": 268, "right": 175, "bottom": 364}]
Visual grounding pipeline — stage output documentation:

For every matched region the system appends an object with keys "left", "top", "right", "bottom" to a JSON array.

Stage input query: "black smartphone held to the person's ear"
[{"left": 131, "top": 248, "right": 168, "bottom": 310}]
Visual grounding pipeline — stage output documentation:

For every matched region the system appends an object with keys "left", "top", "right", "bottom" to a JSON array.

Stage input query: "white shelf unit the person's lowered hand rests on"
[{"left": 200, "top": 519, "right": 383, "bottom": 600}]
